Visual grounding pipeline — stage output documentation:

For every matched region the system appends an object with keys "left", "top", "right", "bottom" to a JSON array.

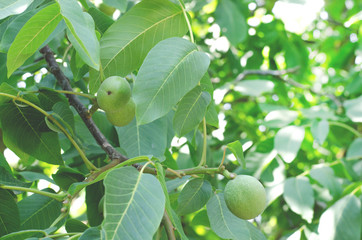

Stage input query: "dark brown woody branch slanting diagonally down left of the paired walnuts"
[{"left": 40, "top": 45, "right": 127, "bottom": 161}]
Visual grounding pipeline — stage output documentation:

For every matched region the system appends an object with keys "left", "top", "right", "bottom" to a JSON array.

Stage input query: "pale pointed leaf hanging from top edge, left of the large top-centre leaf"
[{"left": 57, "top": 0, "right": 100, "bottom": 70}]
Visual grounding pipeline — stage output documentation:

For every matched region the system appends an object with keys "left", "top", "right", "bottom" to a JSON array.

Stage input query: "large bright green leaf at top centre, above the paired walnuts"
[{"left": 89, "top": 0, "right": 187, "bottom": 93}]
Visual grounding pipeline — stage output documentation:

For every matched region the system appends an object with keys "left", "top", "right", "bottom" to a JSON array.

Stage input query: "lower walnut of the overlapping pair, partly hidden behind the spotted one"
[{"left": 106, "top": 98, "right": 136, "bottom": 127}]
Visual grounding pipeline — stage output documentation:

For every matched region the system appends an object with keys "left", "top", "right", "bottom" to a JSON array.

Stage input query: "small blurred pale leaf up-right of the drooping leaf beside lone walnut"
[{"left": 309, "top": 167, "right": 343, "bottom": 197}]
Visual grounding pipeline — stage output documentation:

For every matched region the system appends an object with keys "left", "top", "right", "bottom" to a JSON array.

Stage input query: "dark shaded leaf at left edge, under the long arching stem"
[{"left": 0, "top": 103, "right": 63, "bottom": 165}]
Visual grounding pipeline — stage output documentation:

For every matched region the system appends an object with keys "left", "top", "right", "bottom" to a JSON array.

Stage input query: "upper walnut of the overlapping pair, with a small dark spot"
[{"left": 97, "top": 76, "right": 131, "bottom": 112}]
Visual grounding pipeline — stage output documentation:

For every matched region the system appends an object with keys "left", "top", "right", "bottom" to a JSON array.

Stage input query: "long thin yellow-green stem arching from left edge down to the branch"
[{"left": 0, "top": 92, "right": 98, "bottom": 170}]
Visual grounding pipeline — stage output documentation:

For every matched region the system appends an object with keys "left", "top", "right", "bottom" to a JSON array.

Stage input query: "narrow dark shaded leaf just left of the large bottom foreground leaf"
[{"left": 85, "top": 181, "right": 104, "bottom": 227}]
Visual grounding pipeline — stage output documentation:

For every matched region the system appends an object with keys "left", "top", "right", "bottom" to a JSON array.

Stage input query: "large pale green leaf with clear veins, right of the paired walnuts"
[{"left": 133, "top": 37, "right": 210, "bottom": 124}]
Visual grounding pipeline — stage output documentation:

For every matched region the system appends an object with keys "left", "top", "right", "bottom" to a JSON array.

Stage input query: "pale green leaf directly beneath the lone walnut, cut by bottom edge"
[{"left": 206, "top": 193, "right": 266, "bottom": 240}]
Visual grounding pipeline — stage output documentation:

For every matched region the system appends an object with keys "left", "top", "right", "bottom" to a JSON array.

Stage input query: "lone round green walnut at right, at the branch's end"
[{"left": 224, "top": 175, "right": 266, "bottom": 220}]
